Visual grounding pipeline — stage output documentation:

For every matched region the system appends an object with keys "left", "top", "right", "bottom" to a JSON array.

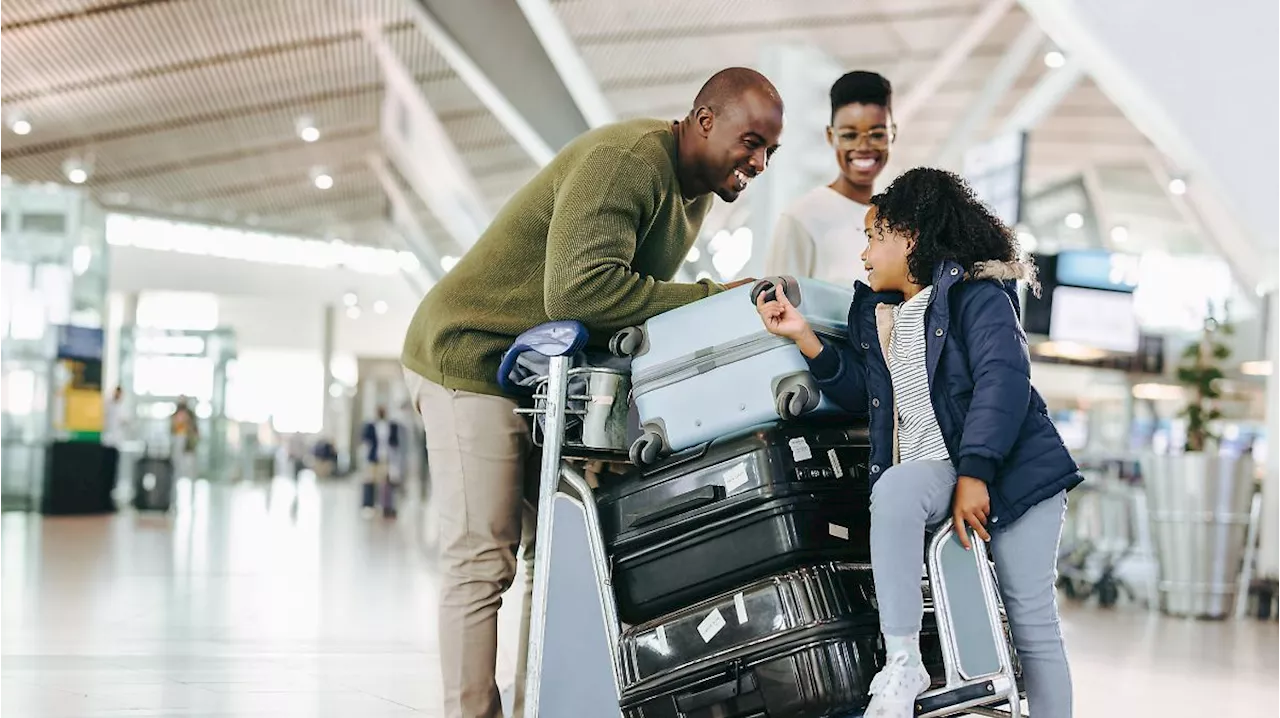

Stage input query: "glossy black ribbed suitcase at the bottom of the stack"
[{"left": 620, "top": 564, "right": 882, "bottom": 718}]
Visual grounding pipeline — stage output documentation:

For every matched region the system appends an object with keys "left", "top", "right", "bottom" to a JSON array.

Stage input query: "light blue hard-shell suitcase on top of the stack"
[{"left": 612, "top": 276, "right": 854, "bottom": 466}]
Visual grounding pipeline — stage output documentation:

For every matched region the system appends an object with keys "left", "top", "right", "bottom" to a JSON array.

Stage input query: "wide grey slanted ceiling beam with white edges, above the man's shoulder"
[{"left": 403, "top": 0, "right": 612, "bottom": 166}]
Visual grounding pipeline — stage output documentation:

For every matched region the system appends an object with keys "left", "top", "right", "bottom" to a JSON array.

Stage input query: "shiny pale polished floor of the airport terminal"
[{"left": 0, "top": 479, "right": 1280, "bottom": 718}]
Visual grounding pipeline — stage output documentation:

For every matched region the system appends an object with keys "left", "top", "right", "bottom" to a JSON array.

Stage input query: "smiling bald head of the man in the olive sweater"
[{"left": 680, "top": 68, "right": 782, "bottom": 202}]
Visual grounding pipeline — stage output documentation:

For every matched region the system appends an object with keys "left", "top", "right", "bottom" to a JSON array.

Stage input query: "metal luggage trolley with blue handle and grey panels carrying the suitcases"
[{"left": 503, "top": 321, "right": 1025, "bottom": 718}]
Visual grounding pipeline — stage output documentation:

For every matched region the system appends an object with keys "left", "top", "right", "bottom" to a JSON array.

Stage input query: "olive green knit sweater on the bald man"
[{"left": 401, "top": 119, "right": 722, "bottom": 394}]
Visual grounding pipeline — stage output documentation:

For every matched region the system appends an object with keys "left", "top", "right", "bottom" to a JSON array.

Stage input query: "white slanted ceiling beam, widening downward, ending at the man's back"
[{"left": 365, "top": 22, "right": 493, "bottom": 251}]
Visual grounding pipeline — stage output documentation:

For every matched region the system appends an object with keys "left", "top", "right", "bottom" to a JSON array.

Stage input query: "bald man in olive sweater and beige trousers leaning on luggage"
[{"left": 401, "top": 68, "right": 782, "bottom": 718}]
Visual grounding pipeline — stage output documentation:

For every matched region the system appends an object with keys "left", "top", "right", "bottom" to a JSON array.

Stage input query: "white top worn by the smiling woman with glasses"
[{"left": 764, "top": 187, "right": 870, "bottom": 287}]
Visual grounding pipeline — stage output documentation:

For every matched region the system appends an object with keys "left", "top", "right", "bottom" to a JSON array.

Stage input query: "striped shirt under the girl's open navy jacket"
[{"left": 888, "top": 287, "right": 950, "bottom": 463}]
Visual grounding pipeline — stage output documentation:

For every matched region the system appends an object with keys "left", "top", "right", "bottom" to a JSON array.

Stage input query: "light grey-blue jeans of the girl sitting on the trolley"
[{"left": 872, "top": 461, "right": 1071, "bottom": 718}]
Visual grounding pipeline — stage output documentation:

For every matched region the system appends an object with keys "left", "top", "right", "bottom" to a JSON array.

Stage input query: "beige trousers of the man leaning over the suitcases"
[{"left": 404, "top": 370, "right": 538, "bottom": 718}]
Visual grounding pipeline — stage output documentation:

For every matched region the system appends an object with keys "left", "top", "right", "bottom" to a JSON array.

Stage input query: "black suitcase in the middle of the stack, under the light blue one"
[{"left": 598, "top": 422, "right": 870, "bottom": 623}]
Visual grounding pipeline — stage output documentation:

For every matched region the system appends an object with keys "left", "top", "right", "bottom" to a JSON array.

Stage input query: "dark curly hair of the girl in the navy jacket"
[{"left": 872, "top": 168, "right": 1039, "bottom": 293}]
